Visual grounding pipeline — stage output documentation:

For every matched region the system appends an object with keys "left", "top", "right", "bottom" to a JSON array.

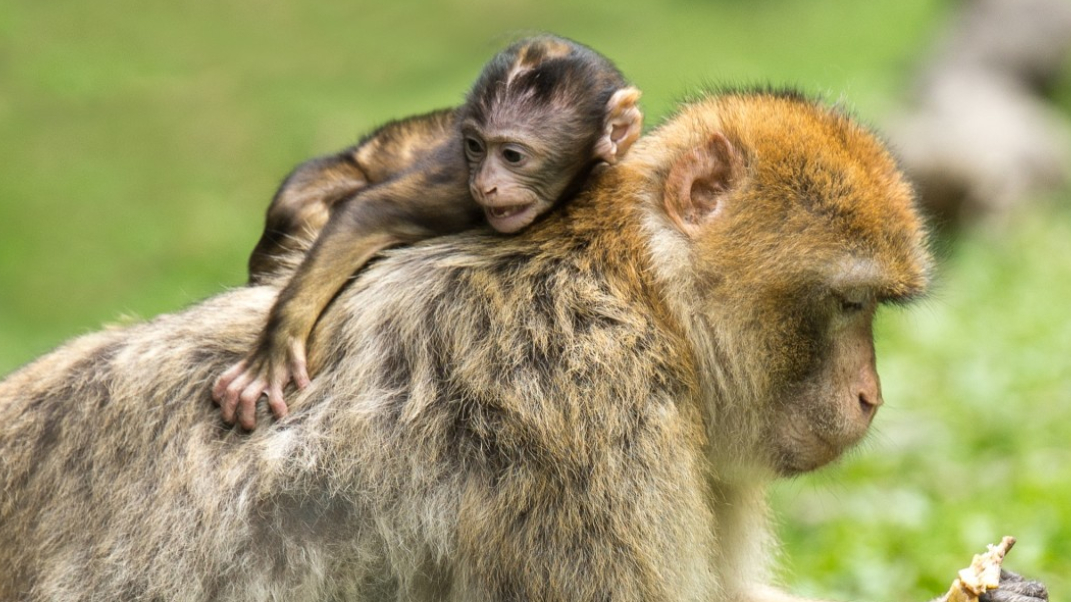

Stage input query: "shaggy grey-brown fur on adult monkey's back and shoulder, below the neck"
[{"left": 0, "top": 228, "right": 711, "bottom": 601}]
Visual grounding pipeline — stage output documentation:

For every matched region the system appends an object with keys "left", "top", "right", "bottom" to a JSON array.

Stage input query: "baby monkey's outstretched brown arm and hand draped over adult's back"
[{"left": 212, "top": 139, "right": 483, "bottom": 428}]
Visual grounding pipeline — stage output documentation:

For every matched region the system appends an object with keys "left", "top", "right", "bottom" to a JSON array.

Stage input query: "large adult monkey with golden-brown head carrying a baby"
[{"left": 0, "top": 93, "right": 1038, "bottom": 602}]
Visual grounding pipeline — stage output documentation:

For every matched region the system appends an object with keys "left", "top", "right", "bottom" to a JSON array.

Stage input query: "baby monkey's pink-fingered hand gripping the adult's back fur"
[{"left": 212, "top": 342, "right": 310, "bottom": 431}]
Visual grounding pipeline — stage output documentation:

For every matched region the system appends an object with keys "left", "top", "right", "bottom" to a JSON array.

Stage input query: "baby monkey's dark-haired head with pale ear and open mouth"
[{"left": 459, "top": 35, "right": 644, "bottom": 232}]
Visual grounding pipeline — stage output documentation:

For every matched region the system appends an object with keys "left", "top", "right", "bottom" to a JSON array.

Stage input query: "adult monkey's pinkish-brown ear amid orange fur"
[{"left": 663, "top": 133, "right": 743, "bottom": 237}]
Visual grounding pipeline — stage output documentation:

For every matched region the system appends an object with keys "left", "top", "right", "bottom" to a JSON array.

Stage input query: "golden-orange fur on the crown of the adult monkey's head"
[{"left": 630, "top": 91, "right": 930, "bottom": 278}]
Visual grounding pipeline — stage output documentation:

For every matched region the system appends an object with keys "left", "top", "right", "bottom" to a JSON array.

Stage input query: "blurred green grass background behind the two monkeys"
[{"left": 0, "top": 0, "right": 1071, "bottom": 602}]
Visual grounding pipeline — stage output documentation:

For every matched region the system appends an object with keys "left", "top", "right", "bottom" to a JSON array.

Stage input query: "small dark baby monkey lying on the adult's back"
[{"left": 212, "top": 35, "right": 643, "bottom": 428}]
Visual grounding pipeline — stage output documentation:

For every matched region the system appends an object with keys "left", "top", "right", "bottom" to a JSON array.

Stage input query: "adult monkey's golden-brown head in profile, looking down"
[{"left": 627, "top": 92, "right": 931, "bottom": 475}]
